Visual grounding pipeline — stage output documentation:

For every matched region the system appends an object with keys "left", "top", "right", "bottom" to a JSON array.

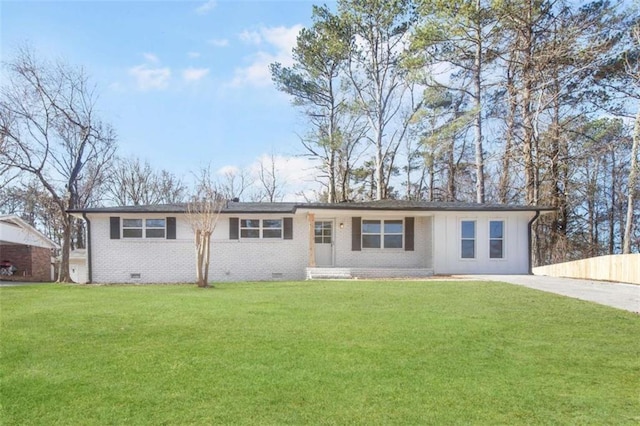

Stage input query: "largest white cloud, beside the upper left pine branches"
[{"left": 231, "top": 24, "right": 302, "bottom": 87}]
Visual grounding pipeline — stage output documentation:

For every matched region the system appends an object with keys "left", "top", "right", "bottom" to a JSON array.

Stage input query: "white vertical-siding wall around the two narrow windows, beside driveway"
[{"left": 433, "top": 211, "right": 535, "bottom": 274}]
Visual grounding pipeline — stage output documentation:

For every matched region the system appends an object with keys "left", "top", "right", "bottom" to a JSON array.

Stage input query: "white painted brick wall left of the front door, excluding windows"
[{"left": 89, "top": 213, "right": 308, "bottom": 283}]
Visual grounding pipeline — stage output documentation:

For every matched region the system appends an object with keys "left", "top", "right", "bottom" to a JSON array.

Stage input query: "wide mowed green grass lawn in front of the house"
[{"left": 0, "top": 281, "right": 640, "bottom": 425}]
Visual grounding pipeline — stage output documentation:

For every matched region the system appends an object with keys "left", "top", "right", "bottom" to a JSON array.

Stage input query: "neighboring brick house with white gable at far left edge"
[{"left": 0, "top": 215, "right": 60, "bottom": 281}]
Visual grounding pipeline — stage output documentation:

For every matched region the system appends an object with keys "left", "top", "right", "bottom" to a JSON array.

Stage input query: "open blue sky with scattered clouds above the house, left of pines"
[{"left": 0, "top": 0, "right": 330, "bottom": 199}]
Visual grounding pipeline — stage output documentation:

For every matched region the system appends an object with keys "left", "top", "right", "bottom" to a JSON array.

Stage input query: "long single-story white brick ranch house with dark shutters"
[{"left": 71, "top": 200, "right": 550, "bottom": 283}]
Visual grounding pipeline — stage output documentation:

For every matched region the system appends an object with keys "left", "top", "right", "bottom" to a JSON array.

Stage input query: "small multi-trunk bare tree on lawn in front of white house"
[{"left": 187, "top": 167, "right": 226, "bottom": 287}]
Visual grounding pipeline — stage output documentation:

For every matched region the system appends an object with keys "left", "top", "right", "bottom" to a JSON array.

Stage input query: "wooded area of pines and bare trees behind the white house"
[{"left": 0, "top": 0, "right": 640, "bottom": 280}]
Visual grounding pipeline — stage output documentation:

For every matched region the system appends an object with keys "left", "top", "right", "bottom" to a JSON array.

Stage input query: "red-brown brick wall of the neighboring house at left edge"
[{"left": 0, "top": 244, "right": 51, "bottom": 281}]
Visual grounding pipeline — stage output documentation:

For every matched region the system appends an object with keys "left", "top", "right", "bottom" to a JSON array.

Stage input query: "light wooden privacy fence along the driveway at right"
[{"left": 533, "top": 254, "right": 640, "bottom": 284}]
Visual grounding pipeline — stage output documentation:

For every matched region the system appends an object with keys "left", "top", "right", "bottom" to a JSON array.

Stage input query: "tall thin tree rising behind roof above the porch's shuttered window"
[{"left": 338, "top": 0, "right": 416, "bottom": 200}]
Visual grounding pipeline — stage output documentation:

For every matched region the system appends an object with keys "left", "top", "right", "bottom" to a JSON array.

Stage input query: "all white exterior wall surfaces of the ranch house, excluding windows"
[{"left": 84, "top": 210, "right": 534, "bottom": 283}]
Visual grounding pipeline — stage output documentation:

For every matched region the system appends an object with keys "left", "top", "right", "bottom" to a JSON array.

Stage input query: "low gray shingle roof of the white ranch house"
[{"left": 69, "top": 200, "right": 554, "bottom": 214}]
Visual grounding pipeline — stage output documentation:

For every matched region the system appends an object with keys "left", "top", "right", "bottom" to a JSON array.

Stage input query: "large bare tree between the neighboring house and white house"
[{"left": 0, "top": 48, "right": 116, "bottom": 282}]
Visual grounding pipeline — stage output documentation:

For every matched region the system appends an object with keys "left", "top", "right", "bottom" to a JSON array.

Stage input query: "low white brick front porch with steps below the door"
[{"left": 305, "top": 267, "right": 433, "bottom": 280}]
